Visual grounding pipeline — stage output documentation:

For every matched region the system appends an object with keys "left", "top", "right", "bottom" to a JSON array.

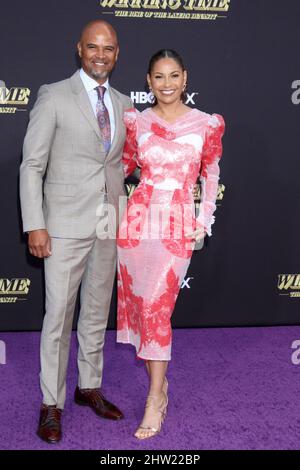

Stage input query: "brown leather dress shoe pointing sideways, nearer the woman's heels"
[{"left": 74, "top": 387, "right": 124, "bottom": 420}]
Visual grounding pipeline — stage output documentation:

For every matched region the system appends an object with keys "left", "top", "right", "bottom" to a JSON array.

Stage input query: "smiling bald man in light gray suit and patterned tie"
[{"left": 20, "top": 20, "right": 132, "bottom": 443}]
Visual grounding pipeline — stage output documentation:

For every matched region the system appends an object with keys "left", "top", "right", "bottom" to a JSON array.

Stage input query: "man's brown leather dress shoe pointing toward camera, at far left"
[{"left": 37, "top": 403, "right": 62, "bottom": 444}]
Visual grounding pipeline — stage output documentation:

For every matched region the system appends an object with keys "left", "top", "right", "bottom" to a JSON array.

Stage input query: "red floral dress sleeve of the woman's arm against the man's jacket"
[{"left": 122, "top": 108, "right": 138, "bottom": 178}]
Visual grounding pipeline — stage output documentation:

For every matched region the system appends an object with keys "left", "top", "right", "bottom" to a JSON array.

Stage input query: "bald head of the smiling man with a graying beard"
[{"left": 77, "top": 20, "right": 119, "bottom": 85}]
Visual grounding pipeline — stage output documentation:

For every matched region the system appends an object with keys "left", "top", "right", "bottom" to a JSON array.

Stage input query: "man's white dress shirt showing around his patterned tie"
[{"left": 79, "top": 69, "right": 116, "bottom": 142}]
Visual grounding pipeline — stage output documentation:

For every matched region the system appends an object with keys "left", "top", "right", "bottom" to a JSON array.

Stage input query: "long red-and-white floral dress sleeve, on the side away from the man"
[{"left": 197, "top": 114, "right": 225, "bottom": 236}]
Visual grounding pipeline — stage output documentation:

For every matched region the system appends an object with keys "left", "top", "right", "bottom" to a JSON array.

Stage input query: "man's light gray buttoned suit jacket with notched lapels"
[{"left": 20, "top": 71, "right": 132, "bottom": 238}]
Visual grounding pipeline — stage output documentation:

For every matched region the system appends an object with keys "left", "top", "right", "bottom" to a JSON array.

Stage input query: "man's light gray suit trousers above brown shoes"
[{"left": 40, "top": 235, "right": 116, "bottom": 409}]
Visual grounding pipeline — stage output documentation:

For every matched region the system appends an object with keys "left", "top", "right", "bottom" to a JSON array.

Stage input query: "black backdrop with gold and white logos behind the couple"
[{"left": 0, "top": 0, "right": 300, "bottom": 331}]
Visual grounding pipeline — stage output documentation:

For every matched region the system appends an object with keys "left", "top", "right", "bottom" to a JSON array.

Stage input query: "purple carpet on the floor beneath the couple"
[{"left": 0, "top": 327, "right": 300, "bottom": 450}]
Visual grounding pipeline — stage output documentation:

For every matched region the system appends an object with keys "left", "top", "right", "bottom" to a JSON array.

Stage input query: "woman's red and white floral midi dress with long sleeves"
[{"left": 117, "top": 108, "right": 225, "bottom": 361}]
